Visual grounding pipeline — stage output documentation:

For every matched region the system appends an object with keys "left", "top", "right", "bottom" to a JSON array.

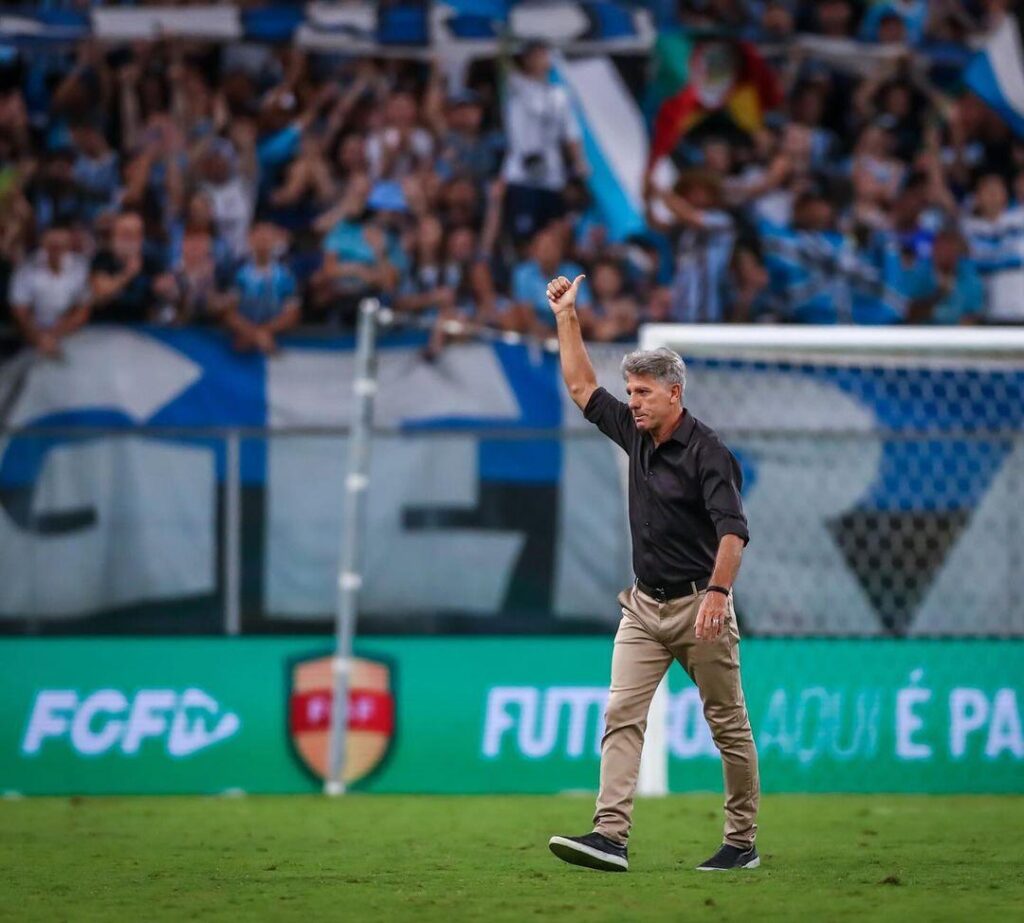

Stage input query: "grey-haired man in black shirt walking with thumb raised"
[{"left": 548, "top": 276, "right": 761, "bottom": 872}]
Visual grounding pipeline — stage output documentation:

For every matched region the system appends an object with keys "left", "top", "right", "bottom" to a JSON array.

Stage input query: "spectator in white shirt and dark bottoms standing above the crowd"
[{"left": 502, "top": 41, "right": 589, "bottom": 242}]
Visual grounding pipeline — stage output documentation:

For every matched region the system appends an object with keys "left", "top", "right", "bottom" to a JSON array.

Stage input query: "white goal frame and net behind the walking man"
[{"left": 639, "top": 325, "right": 1024, "bottom": 795}]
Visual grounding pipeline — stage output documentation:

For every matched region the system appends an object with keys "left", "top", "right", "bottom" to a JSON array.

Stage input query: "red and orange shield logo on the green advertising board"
[{"left": 288, "top": 656, "right": 394, "bottom": 784}]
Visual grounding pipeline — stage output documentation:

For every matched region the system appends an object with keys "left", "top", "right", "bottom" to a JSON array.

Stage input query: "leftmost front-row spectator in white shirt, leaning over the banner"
[{"left": 9, "top": 224, "right": 89, "bottom": 359}]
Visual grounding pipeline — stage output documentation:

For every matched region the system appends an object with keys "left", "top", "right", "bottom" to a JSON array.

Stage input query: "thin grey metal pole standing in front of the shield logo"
[{"left": 324, "top": 298, "right": 380, "bottom": 795}]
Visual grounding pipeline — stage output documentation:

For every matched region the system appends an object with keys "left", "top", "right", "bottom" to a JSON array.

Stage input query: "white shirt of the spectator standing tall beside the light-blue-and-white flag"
[{"left": 502, "top": 74, "right": 581, "bottom": 192}]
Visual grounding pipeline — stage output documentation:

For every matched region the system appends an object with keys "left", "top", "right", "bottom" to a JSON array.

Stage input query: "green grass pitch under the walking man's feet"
[{"left": 0, "top": 795, "right": 1024, "bottom": 923}]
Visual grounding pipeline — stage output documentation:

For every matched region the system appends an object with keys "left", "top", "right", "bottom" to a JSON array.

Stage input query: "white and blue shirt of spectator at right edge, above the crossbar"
[{"left": 964, "top": 208, "right": 1024, "bottom": 324}]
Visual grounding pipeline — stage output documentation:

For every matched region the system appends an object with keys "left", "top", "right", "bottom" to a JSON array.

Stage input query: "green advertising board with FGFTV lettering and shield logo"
[{"left": 0, "top": 637, "right": 1024, "bottom": 794}]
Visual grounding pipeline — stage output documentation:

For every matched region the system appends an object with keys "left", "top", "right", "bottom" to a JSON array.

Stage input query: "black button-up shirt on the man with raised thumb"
[{"left": 584, "top": 388, "right": 750, "bottom": 586}]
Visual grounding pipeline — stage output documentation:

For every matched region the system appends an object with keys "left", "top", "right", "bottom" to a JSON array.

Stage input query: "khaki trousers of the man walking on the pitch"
[{"left": 594, "top": 586, "right": 761, "bottom": 848}]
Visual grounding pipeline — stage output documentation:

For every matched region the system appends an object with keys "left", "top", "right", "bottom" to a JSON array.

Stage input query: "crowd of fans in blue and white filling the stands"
[{"left": 0, "top": 0, "right": 1024, "bottom": 355}]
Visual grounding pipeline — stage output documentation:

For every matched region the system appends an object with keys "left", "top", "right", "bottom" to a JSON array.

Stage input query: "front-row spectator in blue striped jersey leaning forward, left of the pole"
[{"left": 224, "top": 222, "right": 301, "bottom": 355}]
